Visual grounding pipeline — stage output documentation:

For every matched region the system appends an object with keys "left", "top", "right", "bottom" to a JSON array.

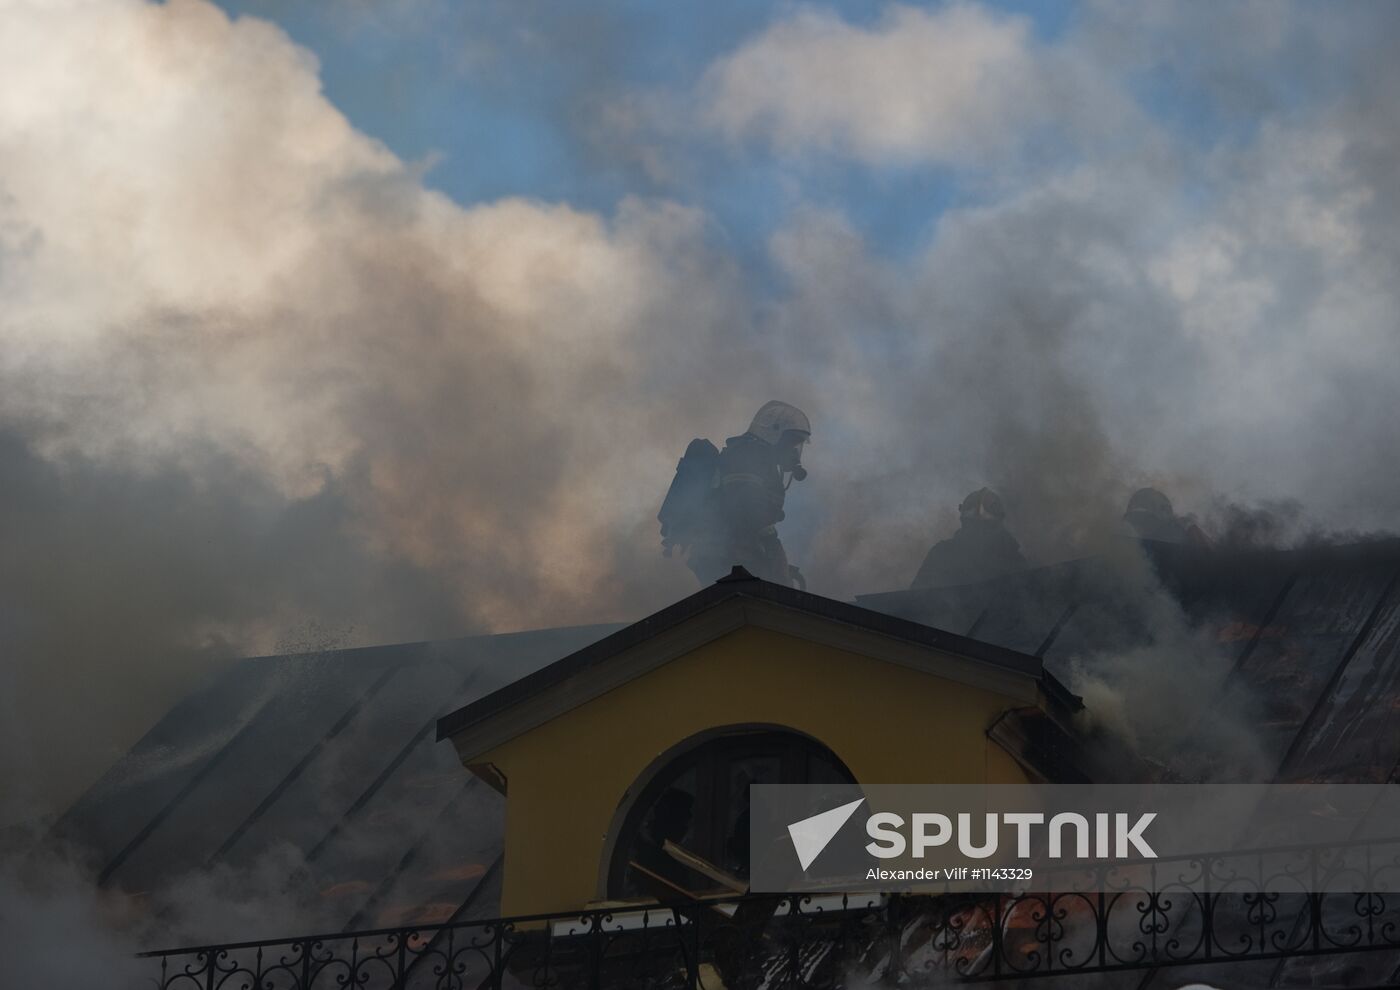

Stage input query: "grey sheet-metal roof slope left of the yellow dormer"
[{"left": 55, "top": 626, "right": 616, "bottom": 938}]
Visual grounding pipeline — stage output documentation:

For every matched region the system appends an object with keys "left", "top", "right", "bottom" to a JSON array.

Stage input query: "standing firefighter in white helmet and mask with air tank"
[{"left": 657, "top": 400, "right": 812, "bottom": 585}]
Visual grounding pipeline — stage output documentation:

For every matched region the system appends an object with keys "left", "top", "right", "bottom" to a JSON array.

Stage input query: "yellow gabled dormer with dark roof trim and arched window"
[{"left": 438, "top": 569, "right": 1079, "bottom": 916}]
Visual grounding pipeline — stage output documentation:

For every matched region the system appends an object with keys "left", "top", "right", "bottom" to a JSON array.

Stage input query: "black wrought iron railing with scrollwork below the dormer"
[{"left": 144, "top": 847, "right": 1400, "bottom": 990}]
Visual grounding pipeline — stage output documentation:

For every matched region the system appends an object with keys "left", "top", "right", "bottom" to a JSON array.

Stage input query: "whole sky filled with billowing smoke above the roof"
[{"left": 0, "top": 0, "right": 1400, "bottom": 974}]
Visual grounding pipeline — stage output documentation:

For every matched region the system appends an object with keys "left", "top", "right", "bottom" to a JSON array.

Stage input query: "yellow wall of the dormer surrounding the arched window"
[{"left": 472, "top": 626, "right": 1029, "bottom": 916}]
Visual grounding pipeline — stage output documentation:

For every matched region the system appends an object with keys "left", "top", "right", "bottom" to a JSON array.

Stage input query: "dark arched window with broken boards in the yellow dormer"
[{"left": 608, "top": 730, "right": 855, "bottom": 899}]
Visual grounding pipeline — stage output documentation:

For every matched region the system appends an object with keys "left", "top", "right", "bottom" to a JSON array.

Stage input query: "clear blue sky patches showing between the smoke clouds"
[{"left": 207, "top": 0, "right": 1075, "bottom": 265}]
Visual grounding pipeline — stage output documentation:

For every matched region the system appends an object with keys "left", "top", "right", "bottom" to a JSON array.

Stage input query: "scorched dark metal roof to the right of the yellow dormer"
[{"left": 857, "top": 539, "right": 1400, "bottom": 783}]
